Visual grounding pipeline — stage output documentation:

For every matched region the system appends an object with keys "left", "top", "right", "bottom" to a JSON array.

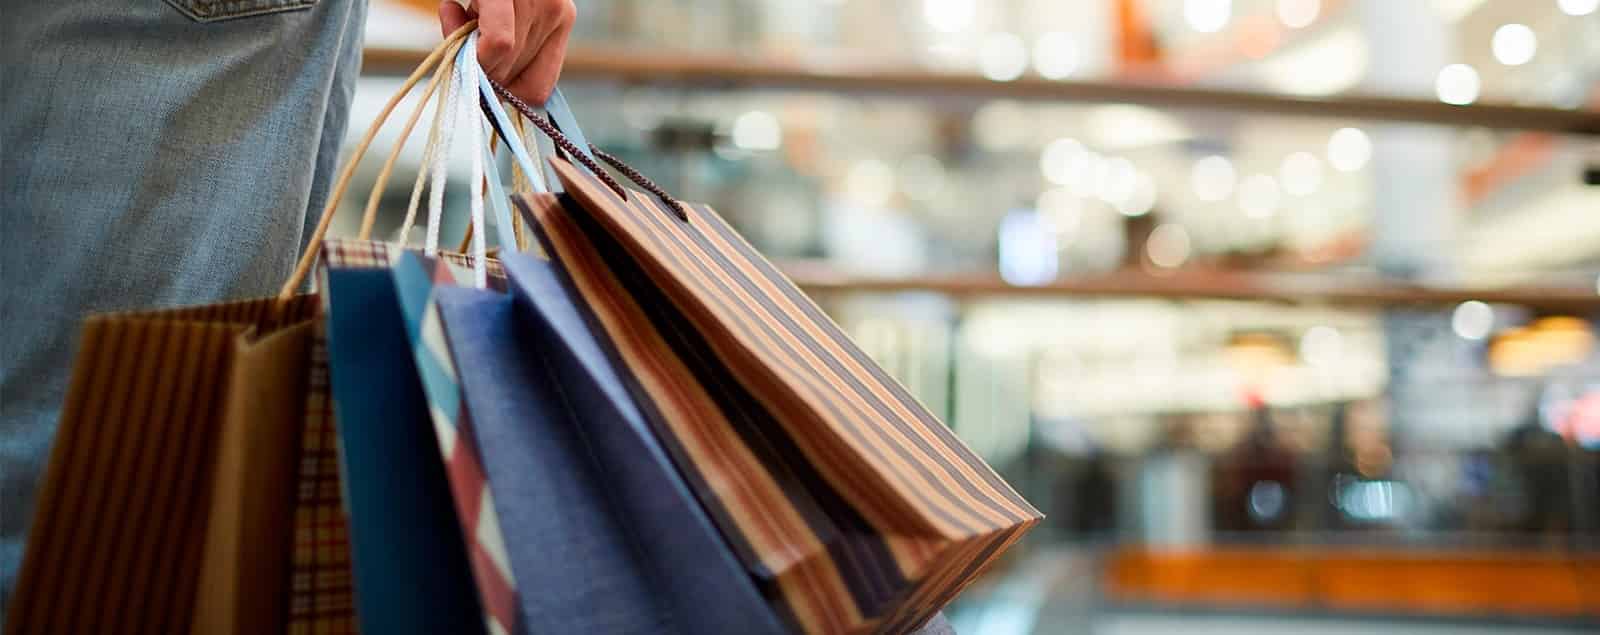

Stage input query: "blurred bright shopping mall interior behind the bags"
[{"left": 336, "top": 0, "right": 1600, "bottom": 635}]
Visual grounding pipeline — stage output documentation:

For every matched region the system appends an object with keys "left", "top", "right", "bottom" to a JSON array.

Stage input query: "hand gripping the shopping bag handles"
[{"left": 438, "top": 0, "right": 578, "bottom": 106}]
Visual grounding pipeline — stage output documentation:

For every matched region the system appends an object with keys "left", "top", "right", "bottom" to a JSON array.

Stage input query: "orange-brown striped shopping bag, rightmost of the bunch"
[{"left": 518, "top": 160, "right": 1040, "bottom": 632}]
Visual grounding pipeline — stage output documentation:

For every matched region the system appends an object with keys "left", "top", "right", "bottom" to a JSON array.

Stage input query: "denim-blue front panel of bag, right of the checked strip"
[{"left": 434, "top": 286, "right": 686, "bottom": 633}]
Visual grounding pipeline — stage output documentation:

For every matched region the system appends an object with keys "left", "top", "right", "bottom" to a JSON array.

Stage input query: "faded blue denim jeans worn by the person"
[{"left": 0, "top": 0, "right": 366, "bottom": 598}]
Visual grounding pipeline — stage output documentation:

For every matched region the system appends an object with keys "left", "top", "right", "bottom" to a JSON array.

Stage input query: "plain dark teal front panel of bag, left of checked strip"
[{"left": 325, "top": 269, "right": 483, "bottom": 633}]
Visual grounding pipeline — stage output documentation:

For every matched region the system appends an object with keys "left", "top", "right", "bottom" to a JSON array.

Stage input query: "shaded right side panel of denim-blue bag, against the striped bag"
[{"left": 501, "top": 253, "right": 784, "bottom": 635}]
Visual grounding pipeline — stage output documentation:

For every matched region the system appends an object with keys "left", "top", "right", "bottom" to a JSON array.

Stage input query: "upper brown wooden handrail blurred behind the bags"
[{"left": 363, "top": 46, "right": 1600, "bottom": 134}]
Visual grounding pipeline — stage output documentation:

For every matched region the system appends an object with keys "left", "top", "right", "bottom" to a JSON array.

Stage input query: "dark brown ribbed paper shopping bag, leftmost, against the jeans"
[{"left": 6, "top": 296, "right": 317, "bottom": 633}]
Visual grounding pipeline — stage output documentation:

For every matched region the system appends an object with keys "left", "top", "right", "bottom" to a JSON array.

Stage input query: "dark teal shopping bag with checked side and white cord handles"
[{"left": 305, "top": 32, "right": 518, "bottom": 633}]
